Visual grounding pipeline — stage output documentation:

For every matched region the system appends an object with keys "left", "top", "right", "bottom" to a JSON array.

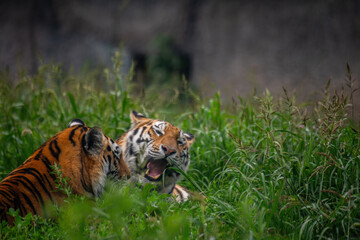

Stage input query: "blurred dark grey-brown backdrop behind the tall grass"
[{"left": 0, "top": 0, "right": 360, "bottom": 108}]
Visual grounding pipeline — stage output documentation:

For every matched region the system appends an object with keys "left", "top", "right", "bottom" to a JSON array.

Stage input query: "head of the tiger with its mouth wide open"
[{"left": 116, "top": 111, "right": 194, "bottom": 193}]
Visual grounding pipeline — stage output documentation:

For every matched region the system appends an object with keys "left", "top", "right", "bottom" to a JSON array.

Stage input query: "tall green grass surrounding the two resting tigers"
[{"left": 0, "top": 55, "right": 360, "bottom": 239}]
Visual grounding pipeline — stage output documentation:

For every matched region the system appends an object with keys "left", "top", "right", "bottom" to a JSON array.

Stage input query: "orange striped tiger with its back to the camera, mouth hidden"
[{"left": 0, "top": 119, "right": 130, "bottom": 225}]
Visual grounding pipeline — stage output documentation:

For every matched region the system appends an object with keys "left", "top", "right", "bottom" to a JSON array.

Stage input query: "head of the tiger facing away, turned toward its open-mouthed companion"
[{"left": 65, "top": 119, "right": 130, "bottom": 197}]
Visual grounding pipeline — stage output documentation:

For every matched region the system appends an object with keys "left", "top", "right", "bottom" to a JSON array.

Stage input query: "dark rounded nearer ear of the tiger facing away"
[{"left": 82, "top": 127, "right": 104, "bottom": 156}]
